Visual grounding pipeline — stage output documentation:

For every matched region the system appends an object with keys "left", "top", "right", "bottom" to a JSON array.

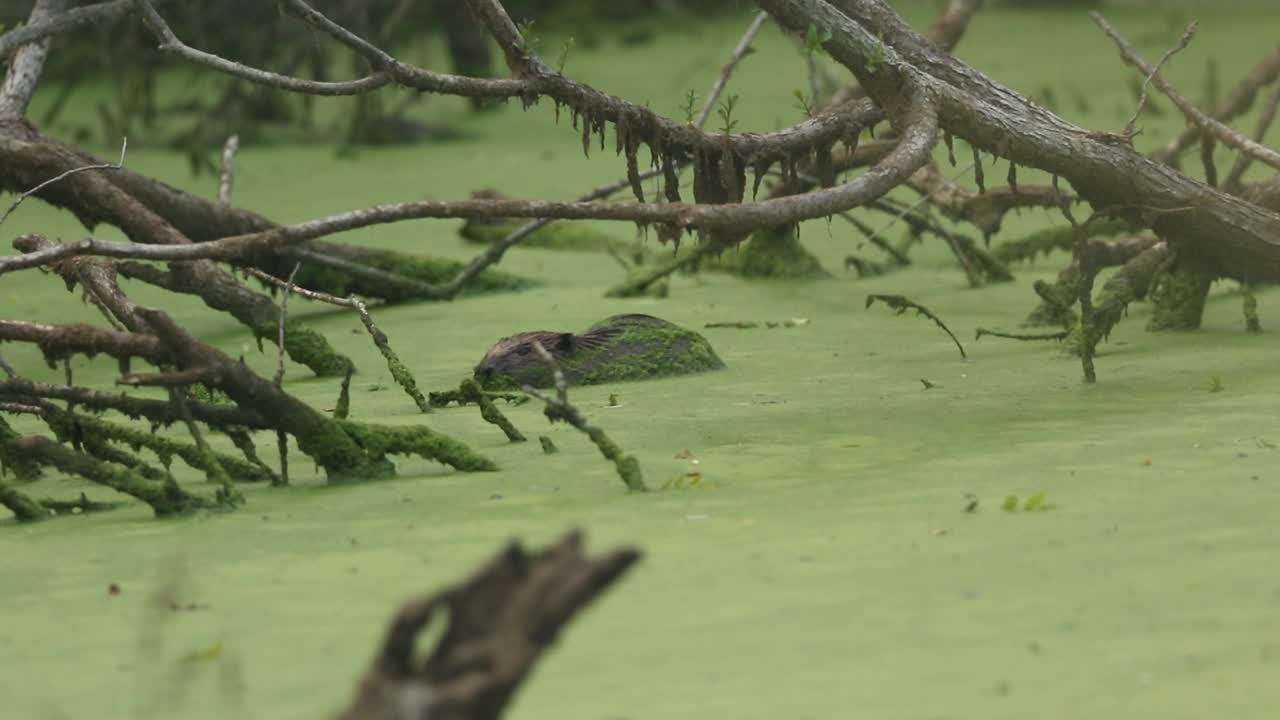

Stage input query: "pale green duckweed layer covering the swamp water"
[{"left": 0, "top": 4, "right": 1280, "bottom": 720}]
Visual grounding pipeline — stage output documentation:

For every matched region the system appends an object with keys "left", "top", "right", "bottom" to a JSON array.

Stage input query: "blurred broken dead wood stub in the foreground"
[{"left": 339, "top": 530, "right": 641, "bottom": 720}]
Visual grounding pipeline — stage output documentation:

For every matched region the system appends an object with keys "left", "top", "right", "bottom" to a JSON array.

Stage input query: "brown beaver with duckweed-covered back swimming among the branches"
[{"left": 475, "top": 313, "right": 724, "bottom": 389}]
